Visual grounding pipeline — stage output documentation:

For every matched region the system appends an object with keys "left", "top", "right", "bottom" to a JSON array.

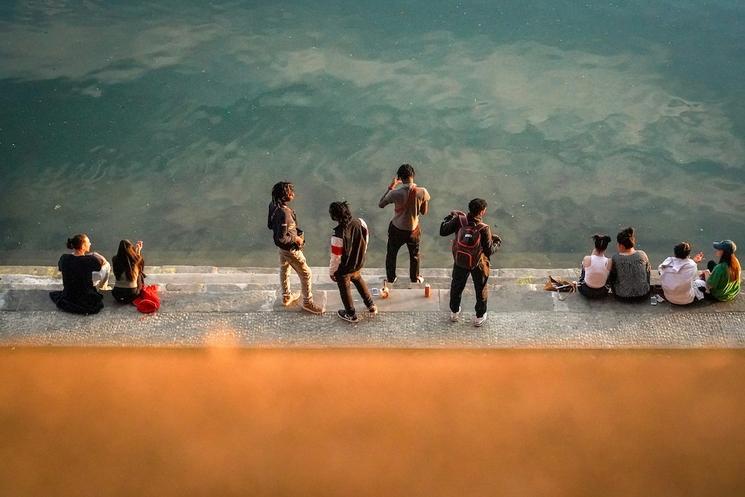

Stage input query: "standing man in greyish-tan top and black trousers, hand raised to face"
[{"left": 378, "top": 164, "right": 430, "bottom": 283}]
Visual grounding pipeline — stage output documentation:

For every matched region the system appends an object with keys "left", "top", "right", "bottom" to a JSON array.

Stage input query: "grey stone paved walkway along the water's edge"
[{"left": 0, "top": 266, "right": 745, "bottom": 348}]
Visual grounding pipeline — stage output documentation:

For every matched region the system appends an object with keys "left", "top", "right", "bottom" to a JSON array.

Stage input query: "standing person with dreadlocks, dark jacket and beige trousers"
[{"left": 267, "top": 181, "right": 324, "bottom": 314}]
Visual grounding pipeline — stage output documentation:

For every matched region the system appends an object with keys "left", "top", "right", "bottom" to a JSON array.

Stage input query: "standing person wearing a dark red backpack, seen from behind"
[{"left": 440, "top": 198, "right": 502, "bottom": 327}]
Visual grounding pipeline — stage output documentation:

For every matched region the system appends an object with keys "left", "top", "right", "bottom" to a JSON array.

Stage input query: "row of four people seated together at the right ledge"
[{"left": 577, "top": 227, "right": 741, "bottom": 305}]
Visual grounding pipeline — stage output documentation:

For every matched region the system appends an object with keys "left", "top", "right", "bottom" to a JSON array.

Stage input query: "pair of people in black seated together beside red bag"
[{"left": 49, "top": 233, "right": 145, "bottom": 314}]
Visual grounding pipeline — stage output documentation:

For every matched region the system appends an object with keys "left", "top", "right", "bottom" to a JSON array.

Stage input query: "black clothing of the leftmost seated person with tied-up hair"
[{"left": 50, "top": 254, "right": 103, "bottom": 314}]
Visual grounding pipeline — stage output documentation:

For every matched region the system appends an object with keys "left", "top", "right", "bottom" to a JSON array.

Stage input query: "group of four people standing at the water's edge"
[{"left": 267, "top": 164, "right": 501, "bottom": 326}]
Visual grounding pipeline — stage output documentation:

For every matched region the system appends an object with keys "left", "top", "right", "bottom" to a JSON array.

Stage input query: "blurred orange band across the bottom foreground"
[{"left": 0, "top": 348, "right": 745, "bottom": 497}]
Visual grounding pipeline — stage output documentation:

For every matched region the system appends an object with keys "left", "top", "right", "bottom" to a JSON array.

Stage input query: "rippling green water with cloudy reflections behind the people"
[{"left": 0, "top": 0, "right": 745, "bottom": 266}]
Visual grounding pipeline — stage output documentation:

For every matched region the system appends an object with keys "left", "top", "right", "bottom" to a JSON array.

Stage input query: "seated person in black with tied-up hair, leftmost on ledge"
[{"left": 49, "top": 233, "right": 109, "bottom": 314}]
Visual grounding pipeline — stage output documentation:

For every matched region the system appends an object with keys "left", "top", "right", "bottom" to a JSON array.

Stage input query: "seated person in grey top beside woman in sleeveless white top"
[{"left": 608, "top": 227, "right": 652, "bottom": 302}]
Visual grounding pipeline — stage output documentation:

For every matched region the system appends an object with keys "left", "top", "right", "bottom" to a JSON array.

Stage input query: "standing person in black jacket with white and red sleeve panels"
[{"left": 329, "top": 202, "right": 378, "bottom": 323}]
